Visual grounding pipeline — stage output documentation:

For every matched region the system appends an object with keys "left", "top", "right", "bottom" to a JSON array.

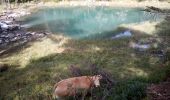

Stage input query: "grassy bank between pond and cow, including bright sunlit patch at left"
[{"left": 0, "top": 20, "right": 169, "bottom": 100}]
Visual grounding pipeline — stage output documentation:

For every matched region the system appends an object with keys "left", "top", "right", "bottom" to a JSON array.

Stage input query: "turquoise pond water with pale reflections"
[{"left": 23, "top": 7, "right": 163, "bottom": 38}]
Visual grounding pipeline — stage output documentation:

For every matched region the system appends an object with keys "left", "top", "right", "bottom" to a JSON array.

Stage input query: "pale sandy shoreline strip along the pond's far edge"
[{"left": 0, "top": 0, "right": 170, "bottom": 12}]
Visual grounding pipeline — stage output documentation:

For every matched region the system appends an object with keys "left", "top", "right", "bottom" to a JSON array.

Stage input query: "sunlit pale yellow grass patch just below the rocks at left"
[{"left": 0, "top": 35, "right": 68, "bottom": 68}]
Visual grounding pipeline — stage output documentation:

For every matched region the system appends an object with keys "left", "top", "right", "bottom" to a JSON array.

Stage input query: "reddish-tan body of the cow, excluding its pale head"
[{"left": 55, "top": 76, "right": 92, "bottom": 96}]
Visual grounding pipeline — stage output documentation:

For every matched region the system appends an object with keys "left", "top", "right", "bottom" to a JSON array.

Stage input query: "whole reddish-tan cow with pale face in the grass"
[{"left": 53, "top": 75, "right": 102, "bottom": 98}]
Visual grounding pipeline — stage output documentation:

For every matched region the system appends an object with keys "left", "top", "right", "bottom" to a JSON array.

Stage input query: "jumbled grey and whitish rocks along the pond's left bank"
[{"left": 0, "top": 9, "right": 47, "bottom": 46}]
